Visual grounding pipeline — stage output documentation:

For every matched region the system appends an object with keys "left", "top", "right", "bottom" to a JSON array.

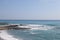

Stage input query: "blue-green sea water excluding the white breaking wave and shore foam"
[{"left": 0, "top": 20, "right": 60, "bottom": 40}]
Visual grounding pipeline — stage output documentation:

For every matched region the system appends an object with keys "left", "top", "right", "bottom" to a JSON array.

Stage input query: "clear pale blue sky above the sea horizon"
[{"left": 0, "top": 0, "right": 60, "bottom": 20}]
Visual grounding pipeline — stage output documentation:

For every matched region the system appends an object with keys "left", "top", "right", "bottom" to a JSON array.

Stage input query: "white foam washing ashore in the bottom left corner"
[{"left": 0, "top": 30, "right": 22, "bottom": 40}]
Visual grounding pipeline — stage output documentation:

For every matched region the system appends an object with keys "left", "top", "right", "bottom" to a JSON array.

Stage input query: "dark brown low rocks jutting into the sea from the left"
[{"left": 0, "top": 24, "right": 30, "bottom": 30}]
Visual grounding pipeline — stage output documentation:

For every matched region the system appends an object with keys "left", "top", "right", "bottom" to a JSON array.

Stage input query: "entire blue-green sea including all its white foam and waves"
[{"left": 0, "top": 20, "right": 60, "bottom": 40}]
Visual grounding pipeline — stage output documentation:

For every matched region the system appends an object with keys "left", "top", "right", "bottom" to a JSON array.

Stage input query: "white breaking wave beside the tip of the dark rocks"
[{"left": 18, "top": 24, "right": 54, "bottom": 30}]
